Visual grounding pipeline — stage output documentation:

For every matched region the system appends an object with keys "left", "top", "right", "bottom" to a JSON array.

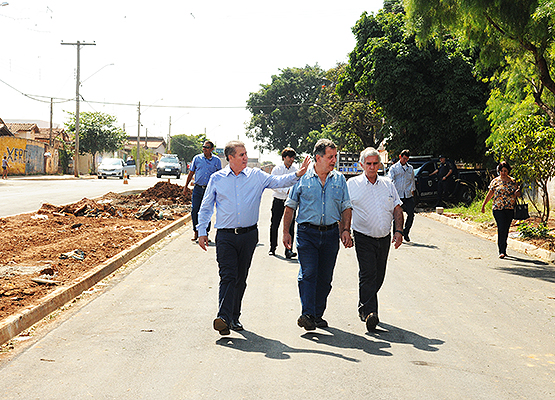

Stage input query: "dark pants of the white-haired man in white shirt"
[{"left": 354, "top": 231, "right": 391, "bottom": 321}]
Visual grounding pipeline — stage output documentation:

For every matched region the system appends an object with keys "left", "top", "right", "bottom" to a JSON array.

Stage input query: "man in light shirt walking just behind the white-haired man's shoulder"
[{"left": 389, "top": 150, "right": 416, "bottom": 242}]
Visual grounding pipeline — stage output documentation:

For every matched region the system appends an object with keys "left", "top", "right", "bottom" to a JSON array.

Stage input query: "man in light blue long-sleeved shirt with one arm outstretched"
[{"left": 198, "top": 141, "right": 310, "bottom": 335}]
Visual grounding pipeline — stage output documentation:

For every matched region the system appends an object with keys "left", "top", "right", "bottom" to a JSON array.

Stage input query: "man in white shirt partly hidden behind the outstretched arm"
[{"left": 268, "top": 147, "right": 297, "bottom": 258}]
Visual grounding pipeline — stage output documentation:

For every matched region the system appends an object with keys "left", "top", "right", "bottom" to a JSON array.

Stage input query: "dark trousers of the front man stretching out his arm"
[{"left": 216, "top": 229, "right": 258, "bottom": 324}]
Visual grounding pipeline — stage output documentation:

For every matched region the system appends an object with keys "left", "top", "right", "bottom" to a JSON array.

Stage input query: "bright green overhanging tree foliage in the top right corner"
[{"left": 405, "top": 0, "right": 555, "bottom": 127}]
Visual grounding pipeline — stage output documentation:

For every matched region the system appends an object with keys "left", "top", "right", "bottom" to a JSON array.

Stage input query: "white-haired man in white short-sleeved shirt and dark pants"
[{"left": 347, "top": 147, "right": 403, "bottom": 331}]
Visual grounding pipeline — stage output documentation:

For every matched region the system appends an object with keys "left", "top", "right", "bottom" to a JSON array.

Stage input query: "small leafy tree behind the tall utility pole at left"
[{"left": 65, "top": 112, "right": 127, "bottom": 172}]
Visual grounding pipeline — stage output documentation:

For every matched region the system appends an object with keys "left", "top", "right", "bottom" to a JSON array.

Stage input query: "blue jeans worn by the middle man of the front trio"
[{"left": 297, "top": 225, "right": 339, "bottom": 317}]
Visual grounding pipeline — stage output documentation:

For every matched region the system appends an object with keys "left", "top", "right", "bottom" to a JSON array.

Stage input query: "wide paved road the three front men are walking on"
[{"left": 0, "top": 192, "right": 555, "bottom": 400}]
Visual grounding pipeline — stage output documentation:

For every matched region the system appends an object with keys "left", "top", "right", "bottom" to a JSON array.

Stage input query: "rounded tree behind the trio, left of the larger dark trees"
[{"left": 247, "top": 65, "right": 329, "bottom": 153}]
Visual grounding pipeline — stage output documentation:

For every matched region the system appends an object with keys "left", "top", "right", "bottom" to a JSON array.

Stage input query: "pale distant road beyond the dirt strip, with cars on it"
[{"left": 0, "top": 176, "right": 178, "bottom": 217}]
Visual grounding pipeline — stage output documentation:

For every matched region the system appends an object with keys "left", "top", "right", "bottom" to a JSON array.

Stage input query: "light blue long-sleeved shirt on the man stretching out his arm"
[{"left": 197, "top": 165, "right": 299, "bottom": 236}]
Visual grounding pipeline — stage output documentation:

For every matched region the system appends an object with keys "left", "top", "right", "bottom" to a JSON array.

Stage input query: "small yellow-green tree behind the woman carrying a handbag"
[{"left": 490, "top": 114, "right": 555, "bottom": 222}]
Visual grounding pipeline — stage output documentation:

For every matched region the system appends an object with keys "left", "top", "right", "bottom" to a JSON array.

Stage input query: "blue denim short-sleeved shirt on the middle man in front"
[{"left": 285, "top": 166, "right": 352, "bottom": 225}]
